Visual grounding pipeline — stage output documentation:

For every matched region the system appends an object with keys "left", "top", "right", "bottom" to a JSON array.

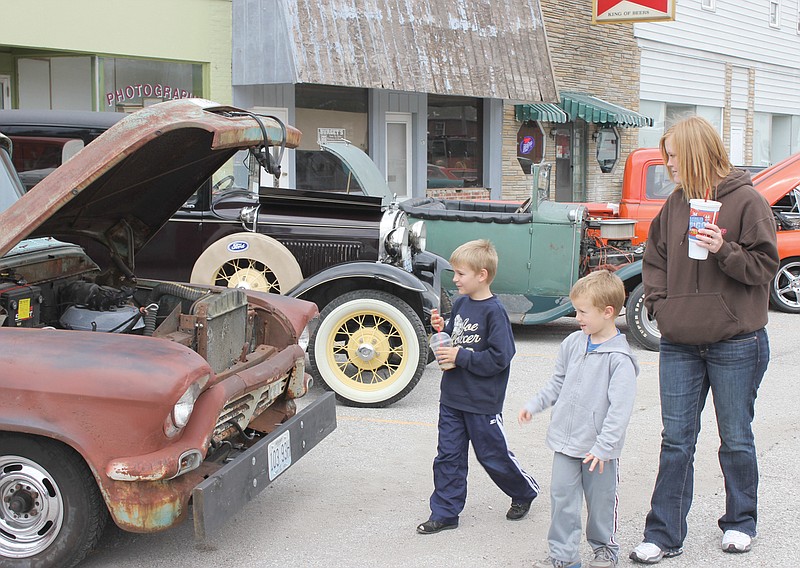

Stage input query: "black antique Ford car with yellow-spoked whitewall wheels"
[{"left": 0, "top": 107, "right": 449, "bottom": 407}]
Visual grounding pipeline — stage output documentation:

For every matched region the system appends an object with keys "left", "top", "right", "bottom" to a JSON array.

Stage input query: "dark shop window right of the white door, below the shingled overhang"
[{"left": 428, "top": 95, "right": 483, "bottom": 188}]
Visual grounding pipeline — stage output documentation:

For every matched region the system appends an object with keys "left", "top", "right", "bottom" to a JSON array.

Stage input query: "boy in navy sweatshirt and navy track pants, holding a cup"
[{"left": 417, "top": 240, "right": 539, "bottom": 534}]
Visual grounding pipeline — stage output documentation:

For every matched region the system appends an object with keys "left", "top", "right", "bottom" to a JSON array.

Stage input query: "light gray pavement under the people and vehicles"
[{"left": 82, "top": 311, "right": 800, "bottom": 568}]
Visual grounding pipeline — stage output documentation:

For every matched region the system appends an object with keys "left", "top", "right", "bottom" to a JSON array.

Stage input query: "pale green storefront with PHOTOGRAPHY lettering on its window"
[{"left": 0, "top": 0, "right": 231, "bottom": 112}]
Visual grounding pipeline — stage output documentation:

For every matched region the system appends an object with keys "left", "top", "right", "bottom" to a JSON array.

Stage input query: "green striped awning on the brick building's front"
[{"left": 514, "top": 91, "right": 653, "bottom": 127}]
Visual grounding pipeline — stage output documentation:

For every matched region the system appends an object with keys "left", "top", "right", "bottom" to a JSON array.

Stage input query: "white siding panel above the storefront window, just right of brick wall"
[{"left": 639, "top": 47, "right": 725, "bottom": 107}]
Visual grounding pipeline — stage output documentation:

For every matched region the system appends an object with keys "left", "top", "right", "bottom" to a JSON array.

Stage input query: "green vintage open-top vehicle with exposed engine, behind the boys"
[{"left": 400, "top": 166, "right": 660, "bottom": 350}]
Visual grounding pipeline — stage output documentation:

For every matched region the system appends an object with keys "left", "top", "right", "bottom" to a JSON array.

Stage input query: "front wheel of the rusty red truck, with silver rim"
[{"left": 0, "top": 434, "right": 108, "bottom": 568}]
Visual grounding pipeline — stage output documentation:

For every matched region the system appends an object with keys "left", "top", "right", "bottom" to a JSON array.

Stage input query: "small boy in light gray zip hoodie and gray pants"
[{"left": 519, "top": 270, "right": 639, "bottom": 568}]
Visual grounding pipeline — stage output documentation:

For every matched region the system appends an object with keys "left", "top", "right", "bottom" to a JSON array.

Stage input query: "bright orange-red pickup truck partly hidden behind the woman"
[{"left": 586, "top": 148, "right": 800, "bottom": 313}]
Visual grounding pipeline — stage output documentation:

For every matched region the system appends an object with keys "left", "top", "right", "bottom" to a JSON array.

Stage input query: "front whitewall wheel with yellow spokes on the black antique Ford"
[{"left": 309, "top": 290, "right": 428, "bottom": 408}]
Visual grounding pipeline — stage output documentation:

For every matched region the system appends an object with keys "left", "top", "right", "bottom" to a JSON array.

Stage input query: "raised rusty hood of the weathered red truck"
[{"left": 0, "top": 99, "right": 300, "bottom": 260}]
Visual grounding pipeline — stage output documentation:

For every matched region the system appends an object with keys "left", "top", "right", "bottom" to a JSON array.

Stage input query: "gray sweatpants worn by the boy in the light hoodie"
[{"left": 547, "top": 452, "right": 619, "bottom": 562}]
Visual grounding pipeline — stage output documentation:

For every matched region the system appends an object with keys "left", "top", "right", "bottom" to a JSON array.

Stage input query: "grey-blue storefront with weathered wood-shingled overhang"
[{"left": 233, "top": 0, "right": 557, "bottom": 199}]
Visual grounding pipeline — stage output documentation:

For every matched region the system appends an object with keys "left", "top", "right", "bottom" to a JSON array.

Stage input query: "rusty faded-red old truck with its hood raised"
[{"left": 0, "top": 99, "right": 336, "bottom": 568}]
